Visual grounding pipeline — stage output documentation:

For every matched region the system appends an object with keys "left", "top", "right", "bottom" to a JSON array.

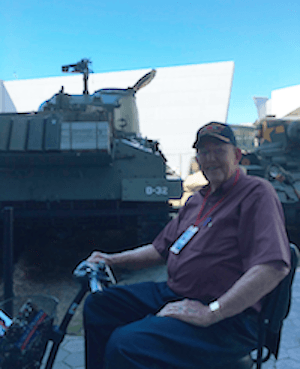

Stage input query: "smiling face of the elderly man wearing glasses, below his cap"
[{"left": 196, "top": 137, "right": 241, "bottom": 190}]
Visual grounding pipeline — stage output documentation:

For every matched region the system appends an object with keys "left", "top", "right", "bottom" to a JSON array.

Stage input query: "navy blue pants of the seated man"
[{"left": 84, "top": 282, "right": 257, "bottom": 369}]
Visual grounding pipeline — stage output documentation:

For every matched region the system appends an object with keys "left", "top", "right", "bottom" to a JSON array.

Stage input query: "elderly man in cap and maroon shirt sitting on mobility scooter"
[{"left": 84, "top": 122, "right": 290, "bottom": 369}]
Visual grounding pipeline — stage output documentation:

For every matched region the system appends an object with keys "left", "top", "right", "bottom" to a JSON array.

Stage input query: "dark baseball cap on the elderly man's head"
[{"left": 193, "top": 122, "right": 236, "bottom": 148}]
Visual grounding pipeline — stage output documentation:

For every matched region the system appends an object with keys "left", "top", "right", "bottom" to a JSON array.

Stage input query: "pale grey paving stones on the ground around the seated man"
[{"left": 41, "top": 267, "right": 300, "bottom": 369}]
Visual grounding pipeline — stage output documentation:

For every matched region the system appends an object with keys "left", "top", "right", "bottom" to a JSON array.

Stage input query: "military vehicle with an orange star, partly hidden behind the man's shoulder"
[{"left": 241, "top": 116, "right": 300, "bottom": 243}]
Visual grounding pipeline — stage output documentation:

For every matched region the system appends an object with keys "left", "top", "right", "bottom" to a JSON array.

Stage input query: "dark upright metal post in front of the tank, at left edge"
[{"left": 3, "top": 207, "right": 14, "bottom": 316}]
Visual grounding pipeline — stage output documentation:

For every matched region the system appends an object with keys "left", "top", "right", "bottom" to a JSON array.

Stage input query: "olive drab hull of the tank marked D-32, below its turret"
[{"left": 0, "top": 113, "right": 180, "bottom": 202}]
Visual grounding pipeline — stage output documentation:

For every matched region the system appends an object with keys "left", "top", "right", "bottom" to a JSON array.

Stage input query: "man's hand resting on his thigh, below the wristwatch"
[{"left": 156, "top": 299, "right": 221, "bottom": 327}]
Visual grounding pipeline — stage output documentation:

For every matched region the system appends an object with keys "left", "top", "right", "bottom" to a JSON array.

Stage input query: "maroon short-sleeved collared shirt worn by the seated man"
[{"left": 153, "top": 171, "right": 290, "bottom": 309}]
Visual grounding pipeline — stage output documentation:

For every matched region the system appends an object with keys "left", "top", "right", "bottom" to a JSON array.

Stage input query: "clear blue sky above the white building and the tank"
[{"left": 0, "top": 0, "right": 300, "bottom": 124}]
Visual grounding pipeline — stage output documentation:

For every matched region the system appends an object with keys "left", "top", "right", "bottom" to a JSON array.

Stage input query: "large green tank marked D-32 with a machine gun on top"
[{"left": 0, "top": 59, "right": 182, "bottom": 268}]
